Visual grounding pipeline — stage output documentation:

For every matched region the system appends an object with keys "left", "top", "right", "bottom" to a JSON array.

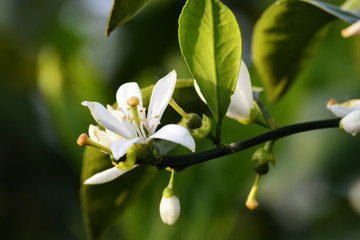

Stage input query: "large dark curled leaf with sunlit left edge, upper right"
[{"left": 253, "top": 0, "right": 360, "bottom": 102}]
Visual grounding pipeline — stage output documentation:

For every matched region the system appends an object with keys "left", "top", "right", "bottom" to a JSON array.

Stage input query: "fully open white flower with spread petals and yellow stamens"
[{"left": 82, "top": 71, "right": 195, "bottom": 184}]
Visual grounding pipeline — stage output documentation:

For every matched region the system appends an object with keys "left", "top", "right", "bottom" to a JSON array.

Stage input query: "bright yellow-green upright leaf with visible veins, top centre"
[{"left": 179, "top": 0, "right": 241, "bottom": 137}]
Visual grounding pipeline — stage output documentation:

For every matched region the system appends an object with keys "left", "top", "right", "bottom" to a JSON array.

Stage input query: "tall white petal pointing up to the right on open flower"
[{"left": 147, "top": 70, "right": 176, "bottom": 134}]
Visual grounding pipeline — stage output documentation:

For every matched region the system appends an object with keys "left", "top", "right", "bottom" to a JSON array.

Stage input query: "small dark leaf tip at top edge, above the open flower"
[{"left": 106, "top": 0, "right": 149, "bottom": 36}]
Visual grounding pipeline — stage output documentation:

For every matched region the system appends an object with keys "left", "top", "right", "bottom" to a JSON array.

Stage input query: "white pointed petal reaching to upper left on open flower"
[{"left": 81, "top": 101, "right": 131, "bottom": 138}]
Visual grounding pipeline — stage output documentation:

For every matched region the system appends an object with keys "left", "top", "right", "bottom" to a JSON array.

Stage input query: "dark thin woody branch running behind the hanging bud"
[{"left": 157, "top": 118, "right": 340, "bottom": 171}]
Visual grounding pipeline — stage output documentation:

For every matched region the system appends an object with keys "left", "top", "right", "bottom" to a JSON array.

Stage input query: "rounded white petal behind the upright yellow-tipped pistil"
[{"left": 116, "top": 82, "right": 143, "bottom": 113}]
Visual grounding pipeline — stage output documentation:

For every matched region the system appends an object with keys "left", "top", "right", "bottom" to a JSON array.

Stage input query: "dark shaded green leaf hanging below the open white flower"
[{"left": 80, "top": 147, "right": 157, "bottom": 239}]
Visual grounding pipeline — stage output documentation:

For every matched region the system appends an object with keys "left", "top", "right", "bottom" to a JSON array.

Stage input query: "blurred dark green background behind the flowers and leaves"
[{"left": 0, "top": 0, "right": 360, "bottom": 240}]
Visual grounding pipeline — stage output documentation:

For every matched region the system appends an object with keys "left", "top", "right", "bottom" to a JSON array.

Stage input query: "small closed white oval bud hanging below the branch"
[{"left": 160, "top": 195, "right": 180, "bottom": 225}]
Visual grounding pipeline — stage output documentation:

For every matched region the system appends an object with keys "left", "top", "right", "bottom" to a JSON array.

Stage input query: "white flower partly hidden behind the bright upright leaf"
[{"left": 195, "top": 60, "right": 256, "bottom": 124}]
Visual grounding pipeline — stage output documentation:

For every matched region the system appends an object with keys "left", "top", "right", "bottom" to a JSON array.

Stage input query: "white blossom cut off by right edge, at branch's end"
[{"left": 327, "top": 99, "right": 360, "bottom": 135}]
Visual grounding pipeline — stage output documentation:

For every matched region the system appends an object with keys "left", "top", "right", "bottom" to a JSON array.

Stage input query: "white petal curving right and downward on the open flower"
[{"left": 147, "top": 124, "right": 195, "bottom": 152}]
